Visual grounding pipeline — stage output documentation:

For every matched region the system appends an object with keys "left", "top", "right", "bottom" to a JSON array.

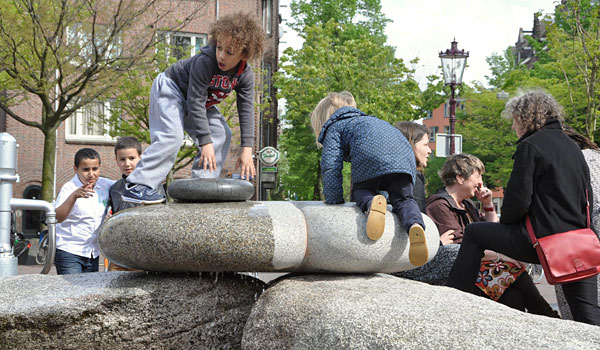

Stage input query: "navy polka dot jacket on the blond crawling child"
[{"left": 319, "top": 107, "right": 417, "bottom": 204}]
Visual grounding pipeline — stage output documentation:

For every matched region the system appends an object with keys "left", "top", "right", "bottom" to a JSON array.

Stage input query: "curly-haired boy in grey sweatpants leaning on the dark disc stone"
[{"left": 123, "top": 13, "right": 264, "bottom": 204}]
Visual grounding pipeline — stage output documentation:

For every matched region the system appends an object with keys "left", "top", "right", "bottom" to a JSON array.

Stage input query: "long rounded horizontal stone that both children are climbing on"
[{"left": 99, "top": 201, "right": 439, "bottom": 273}]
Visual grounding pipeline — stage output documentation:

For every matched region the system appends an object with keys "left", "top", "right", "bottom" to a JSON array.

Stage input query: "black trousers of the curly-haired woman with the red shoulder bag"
[{"left": 448, "top": 222, "right": 600, "bottom": 325}]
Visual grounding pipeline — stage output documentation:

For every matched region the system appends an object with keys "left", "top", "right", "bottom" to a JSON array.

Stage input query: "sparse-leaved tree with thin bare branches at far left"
[{"left": 0, "top": 0, "right": 204, "bottom": 201}]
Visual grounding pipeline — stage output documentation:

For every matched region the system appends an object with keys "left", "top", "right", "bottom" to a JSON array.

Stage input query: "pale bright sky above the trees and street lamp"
[{"left": 279, "top": 0, "right": 558, "bottom": 89}]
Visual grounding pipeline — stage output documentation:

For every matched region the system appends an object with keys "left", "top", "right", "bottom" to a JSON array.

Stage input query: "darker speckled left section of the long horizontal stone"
[{"left": 99, "top": 202, "right": 274, "bottom": 272}]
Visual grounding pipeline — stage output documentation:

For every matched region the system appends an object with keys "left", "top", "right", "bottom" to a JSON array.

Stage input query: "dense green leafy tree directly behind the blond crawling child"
[{"left": 276, "top": 0, "right": 425, "bottom": 200}]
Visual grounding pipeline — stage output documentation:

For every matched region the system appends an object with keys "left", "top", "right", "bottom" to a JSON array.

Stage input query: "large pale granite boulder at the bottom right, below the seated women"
[{"left": 242, "top": 274, "right": 600, "bottom": 350}]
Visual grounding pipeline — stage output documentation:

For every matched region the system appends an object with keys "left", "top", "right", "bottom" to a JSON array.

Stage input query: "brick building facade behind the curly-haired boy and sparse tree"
[{"left": 0, "top": 0, "right": 280, "bottom": 233}]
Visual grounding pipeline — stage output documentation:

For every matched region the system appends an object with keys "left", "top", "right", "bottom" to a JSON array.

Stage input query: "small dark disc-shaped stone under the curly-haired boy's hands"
[{"left": 167, "top": 178, "right": 254, "bottom": 203}]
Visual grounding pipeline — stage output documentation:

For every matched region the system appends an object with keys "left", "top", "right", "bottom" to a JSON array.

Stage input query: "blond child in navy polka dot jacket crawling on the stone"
[{"left": 310, "top": 91, "right": 428, "bottom": 266}]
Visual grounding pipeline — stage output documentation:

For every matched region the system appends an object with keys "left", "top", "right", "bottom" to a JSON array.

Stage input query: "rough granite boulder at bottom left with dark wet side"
[{"left": 0, "top": 272, "right": 265, "bottom": 350}]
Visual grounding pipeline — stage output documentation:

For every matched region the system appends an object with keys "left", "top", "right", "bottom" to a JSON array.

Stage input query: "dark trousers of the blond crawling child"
[{"left": 351, "top": 173, "right": 425, "bottom": 232}]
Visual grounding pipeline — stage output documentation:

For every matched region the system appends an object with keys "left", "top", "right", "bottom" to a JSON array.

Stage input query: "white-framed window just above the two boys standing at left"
[{"left": 65, "top": 101, "right": 113, "bottom": 141}]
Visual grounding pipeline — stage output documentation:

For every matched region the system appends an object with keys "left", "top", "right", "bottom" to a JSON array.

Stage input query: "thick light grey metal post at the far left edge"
[{"left": 0, "top": 132, "right": 19, "bottom": 277}]
